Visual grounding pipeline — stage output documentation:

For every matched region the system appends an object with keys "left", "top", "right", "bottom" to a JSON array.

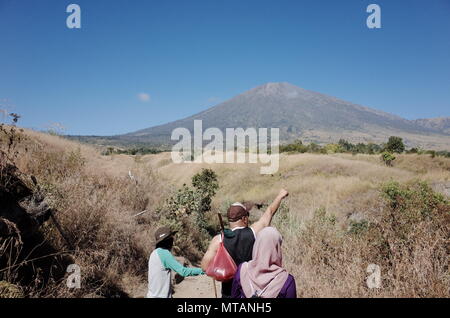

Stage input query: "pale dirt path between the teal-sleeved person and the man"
[{"left": 173, "top": 275, "right": 220, "bottom": 298}]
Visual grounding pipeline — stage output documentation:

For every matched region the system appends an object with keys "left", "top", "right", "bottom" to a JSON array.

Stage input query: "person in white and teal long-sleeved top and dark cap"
[{"left": 147, "top": 227, "right": 205, "bottom": 298}]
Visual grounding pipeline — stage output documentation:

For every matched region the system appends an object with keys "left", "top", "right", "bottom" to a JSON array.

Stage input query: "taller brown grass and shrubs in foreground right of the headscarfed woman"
[{"left": 275, "top": 182, "right": 450, "bottom": 297}]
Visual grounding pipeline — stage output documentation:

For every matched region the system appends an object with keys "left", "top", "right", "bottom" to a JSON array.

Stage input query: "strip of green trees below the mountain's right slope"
[{"left": 280, "top": 136, "right": 450, "bottom": 157}]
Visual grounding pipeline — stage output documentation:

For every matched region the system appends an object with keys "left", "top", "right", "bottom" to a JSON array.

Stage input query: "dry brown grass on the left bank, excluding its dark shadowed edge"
[{"left": 1, "top": 127, "right": 169, "bottom": 297}]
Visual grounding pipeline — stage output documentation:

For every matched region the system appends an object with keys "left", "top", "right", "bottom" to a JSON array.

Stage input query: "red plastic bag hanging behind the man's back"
[{"left": 206, "top": 234, "right": 237, "bottom": 282}]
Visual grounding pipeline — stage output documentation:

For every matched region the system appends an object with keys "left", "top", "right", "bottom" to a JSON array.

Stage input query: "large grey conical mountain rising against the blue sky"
[{"left": 79, "top": 83, "right": 450, "bottom": 150}]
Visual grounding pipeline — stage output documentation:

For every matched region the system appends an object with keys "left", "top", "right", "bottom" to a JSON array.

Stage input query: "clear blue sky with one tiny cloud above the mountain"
[{"left": 0, "top": 0, "right": 450, "bottom": 135}]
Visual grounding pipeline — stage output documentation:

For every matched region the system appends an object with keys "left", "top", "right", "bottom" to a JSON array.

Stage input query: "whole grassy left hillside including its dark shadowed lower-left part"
[{"left": 0, "top": 125, "right": 167, "bottom": 298}]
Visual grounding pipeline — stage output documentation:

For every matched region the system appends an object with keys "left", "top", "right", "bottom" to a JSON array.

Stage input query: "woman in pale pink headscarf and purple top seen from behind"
[{"left": 231, "top": 227, "right": 297, "bottom": 298}]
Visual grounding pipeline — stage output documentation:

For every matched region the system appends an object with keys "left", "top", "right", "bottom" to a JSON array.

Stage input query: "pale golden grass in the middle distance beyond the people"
[{"left": 139, "top": 153, "right": 450, "bottom": 224}]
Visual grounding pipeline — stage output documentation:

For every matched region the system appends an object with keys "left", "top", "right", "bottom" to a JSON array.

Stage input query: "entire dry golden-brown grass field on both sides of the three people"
[{"left": 0, "top": 130, "right": 450, "bottom": 297}]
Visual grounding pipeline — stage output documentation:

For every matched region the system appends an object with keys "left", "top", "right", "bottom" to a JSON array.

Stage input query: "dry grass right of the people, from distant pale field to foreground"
[{"left": 138, "top": 150, "right": 450, "bottom": 297}]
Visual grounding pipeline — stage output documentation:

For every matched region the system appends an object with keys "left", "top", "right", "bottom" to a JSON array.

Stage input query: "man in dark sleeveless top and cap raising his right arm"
[{"left": 201, "top": 189, "right": 289, "bottom": 298}]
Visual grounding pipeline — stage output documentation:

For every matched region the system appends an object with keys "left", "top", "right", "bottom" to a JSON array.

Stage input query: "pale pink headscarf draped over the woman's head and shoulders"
[{"left": 241, "top": 227, "right": 289, "bottom": 298}]
